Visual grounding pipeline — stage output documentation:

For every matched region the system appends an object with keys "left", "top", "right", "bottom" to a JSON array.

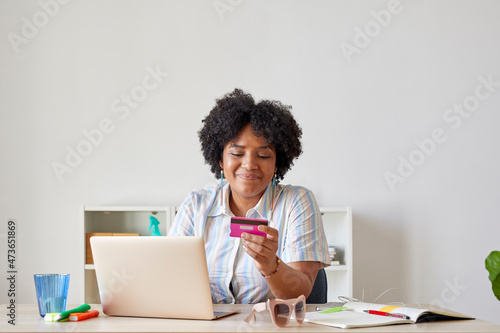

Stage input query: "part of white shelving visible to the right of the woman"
[{"left": 320, "top": 207, "right": 353, "bottom": 302}]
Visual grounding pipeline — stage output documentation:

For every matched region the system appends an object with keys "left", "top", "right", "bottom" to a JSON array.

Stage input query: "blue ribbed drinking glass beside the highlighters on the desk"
[{"left": 34, "top": 274, "right": 69, "bottom": 317}]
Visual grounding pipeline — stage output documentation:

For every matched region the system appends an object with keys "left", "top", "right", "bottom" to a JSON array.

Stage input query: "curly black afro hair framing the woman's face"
[{"left": 198, "top": 89, "right": 302, "bottom": 181}]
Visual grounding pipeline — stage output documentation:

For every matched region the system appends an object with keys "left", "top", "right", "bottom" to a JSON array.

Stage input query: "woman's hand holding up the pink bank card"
[{"left": 241, "top": 225, "right": 279, "bottom": 274}]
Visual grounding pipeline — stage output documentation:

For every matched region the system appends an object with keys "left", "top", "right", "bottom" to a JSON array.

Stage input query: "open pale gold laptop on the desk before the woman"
[{"left": 90, "top": 236, "right": 239, "bottom": 320}]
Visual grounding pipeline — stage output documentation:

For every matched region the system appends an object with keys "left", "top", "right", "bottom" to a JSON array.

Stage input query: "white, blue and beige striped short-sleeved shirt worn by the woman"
[{"left": 169, "top": 183, "right": 330, "bottom": 304}]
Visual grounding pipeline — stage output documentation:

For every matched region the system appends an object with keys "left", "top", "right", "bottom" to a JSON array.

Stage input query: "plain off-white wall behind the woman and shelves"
[{"left": 0, "top": 0, "right": 500, "bottom": 323}]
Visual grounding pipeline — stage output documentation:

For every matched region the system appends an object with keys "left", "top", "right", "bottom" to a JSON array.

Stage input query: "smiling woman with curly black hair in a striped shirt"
[{"left": 169, "top": 89, "right": 330, "bottom": 304}]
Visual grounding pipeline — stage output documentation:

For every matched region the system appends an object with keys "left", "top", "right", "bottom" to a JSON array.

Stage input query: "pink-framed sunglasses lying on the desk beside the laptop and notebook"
[{"left": 245, "top": 295, "right": 306, "bottom": 327}]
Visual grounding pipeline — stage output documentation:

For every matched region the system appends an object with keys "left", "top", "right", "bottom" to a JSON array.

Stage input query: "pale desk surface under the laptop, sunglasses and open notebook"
[{"left": 0, "top": 304, "right": 500, "bottom": 333}]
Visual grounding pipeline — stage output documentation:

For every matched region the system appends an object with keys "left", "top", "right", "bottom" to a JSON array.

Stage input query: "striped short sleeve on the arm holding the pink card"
[{"left": 281, "top": 187, "right": 330, "bottom": 267}]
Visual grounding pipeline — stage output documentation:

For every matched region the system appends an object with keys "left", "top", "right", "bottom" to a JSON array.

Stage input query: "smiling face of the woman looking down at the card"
[{"left": 220, "top": 124, "right": 276, "bottom": 214}]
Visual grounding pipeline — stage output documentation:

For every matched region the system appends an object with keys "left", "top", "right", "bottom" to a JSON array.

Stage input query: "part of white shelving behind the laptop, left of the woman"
[{"left": 81, "top": 206, "right": 175, "bottom": 304}]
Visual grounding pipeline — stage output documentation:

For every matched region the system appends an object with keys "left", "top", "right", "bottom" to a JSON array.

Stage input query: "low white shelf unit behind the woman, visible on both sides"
[{"left": 81, "top": 206, "right": 353, "bottom": 304}]
